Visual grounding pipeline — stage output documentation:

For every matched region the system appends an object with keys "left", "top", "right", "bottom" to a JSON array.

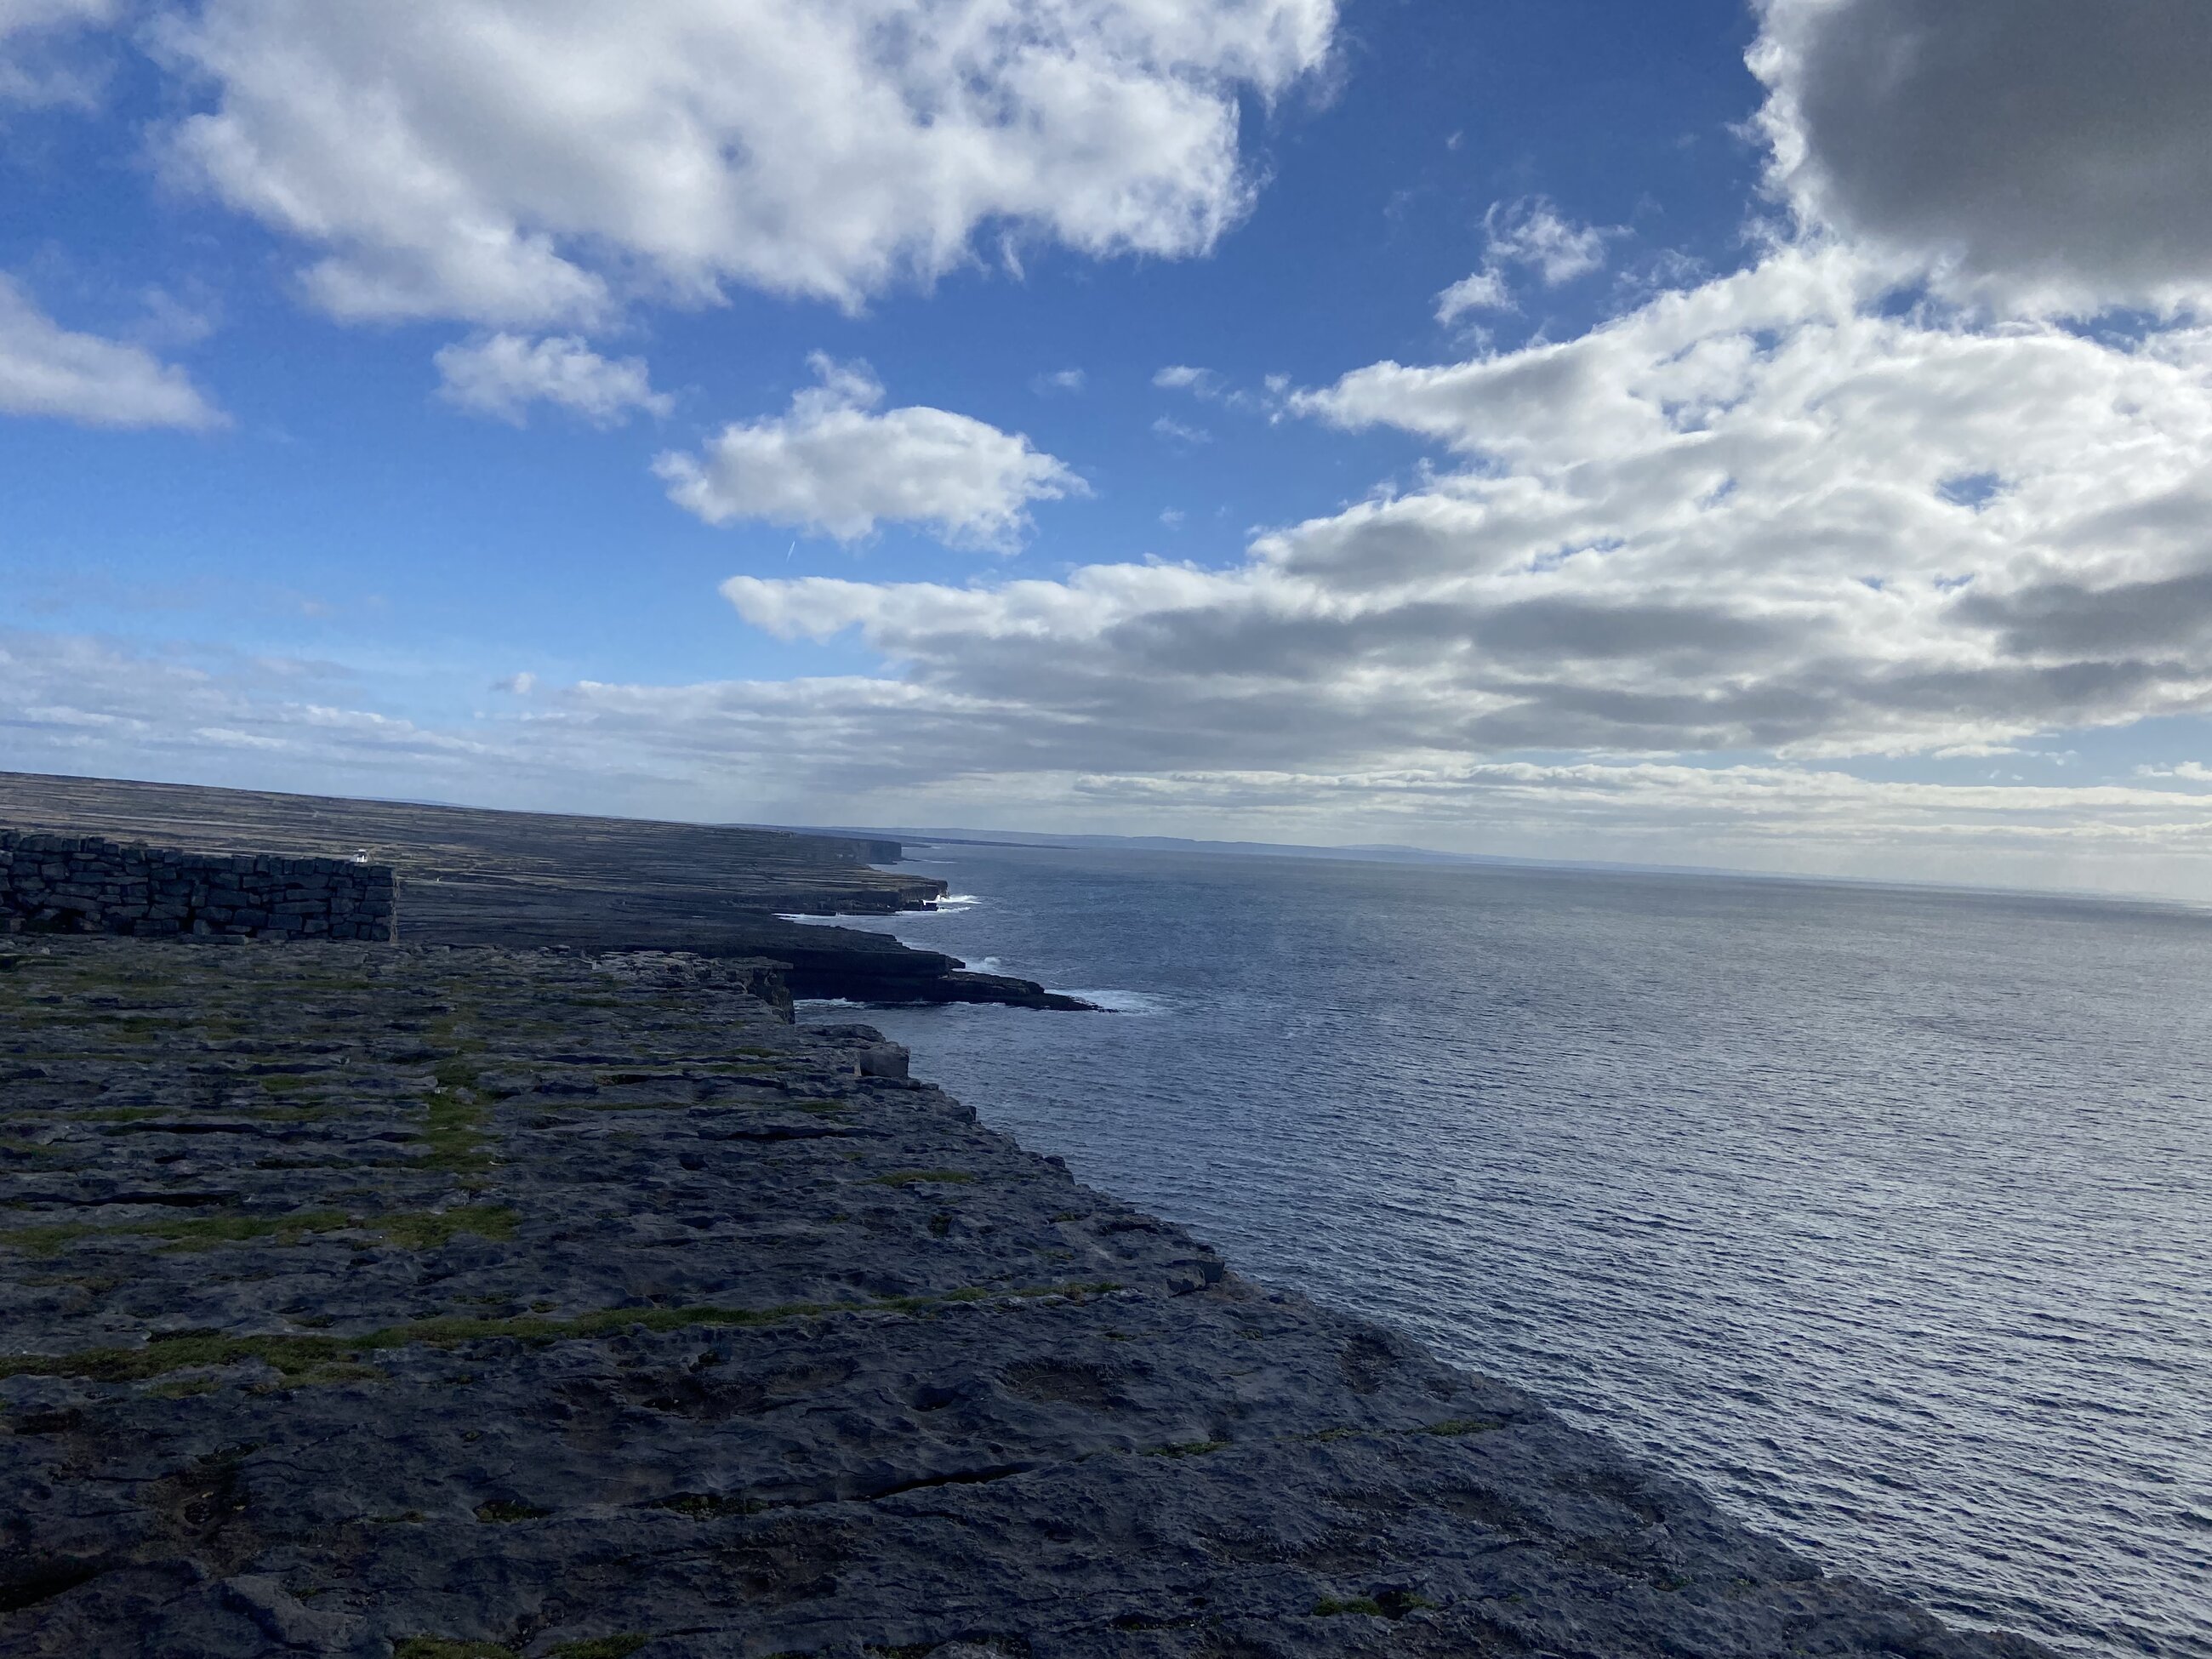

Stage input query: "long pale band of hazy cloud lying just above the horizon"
[{"left": 13, "top": 633, "right": 2212, "bottom": 893}]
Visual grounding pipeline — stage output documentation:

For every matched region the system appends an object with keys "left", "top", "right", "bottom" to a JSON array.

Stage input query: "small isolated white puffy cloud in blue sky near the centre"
[{"left": 655, "top": 354, "right": 1091, "bottom": 550}]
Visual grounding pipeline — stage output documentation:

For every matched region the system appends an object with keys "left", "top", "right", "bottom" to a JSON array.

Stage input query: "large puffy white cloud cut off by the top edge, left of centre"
[{"left": 162, "top": 0, "right": 1336, "bottom": 328}]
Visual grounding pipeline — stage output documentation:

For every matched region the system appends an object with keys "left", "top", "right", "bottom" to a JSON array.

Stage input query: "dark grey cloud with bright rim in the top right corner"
[{"left": 1750, "top": 0, "right": 2212, "bottom": 312}]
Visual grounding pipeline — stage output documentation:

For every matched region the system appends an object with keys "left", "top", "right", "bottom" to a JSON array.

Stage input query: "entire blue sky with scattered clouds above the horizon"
[{"left": 0, "top": 0, "right": 2212, "bottom": 900}]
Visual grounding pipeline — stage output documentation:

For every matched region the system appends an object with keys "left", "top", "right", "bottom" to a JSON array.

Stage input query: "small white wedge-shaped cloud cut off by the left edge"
[{"left": 0, "top": 276, "right": 225, "bottom": 431}]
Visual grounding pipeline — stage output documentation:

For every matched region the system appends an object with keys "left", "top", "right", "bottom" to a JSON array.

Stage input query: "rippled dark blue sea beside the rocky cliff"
[{"left": 795, "top": 847, "right": 2212, "bottom": 1656}]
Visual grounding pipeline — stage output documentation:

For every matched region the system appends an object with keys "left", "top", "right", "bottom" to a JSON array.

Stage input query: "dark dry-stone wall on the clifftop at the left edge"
[{"left": 0, "top": 830, "right": 398, "bottom": 940}]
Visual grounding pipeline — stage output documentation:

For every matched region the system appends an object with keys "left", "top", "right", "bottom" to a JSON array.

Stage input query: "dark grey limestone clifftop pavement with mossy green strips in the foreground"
[{"left": 0, "top": 940, "right": 2039, "bottom": 1659}]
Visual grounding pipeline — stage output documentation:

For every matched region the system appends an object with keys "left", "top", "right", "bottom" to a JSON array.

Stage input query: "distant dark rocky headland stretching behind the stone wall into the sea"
[{"left": 0, "top": 772, "right": 1091, "bottom": 1009}]
